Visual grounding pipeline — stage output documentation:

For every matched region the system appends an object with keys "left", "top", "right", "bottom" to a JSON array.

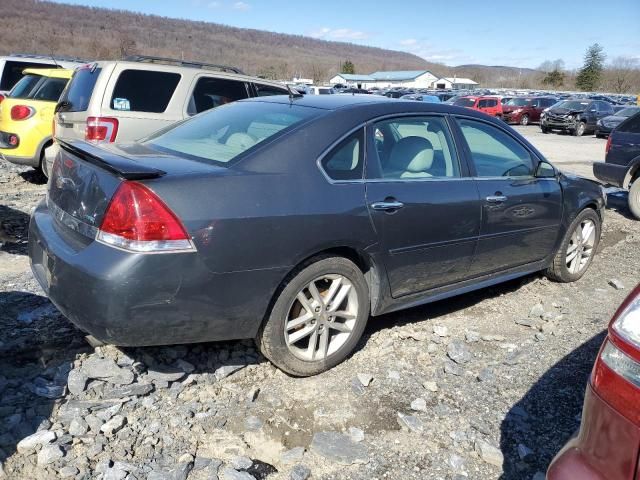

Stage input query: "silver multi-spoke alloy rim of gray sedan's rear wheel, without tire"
[{"left": 284, "top": 274, "right": 358, "bottom": 361}]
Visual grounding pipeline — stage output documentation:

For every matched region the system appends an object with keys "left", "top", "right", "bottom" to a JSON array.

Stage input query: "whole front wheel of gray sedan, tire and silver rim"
[{"left": 546, "top": 208, "right": 602, "bottom": 283}]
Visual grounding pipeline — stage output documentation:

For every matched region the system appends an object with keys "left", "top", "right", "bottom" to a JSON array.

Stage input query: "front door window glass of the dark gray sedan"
[{"left": 458, "top": 119, "right": 533, "bottom": 177}]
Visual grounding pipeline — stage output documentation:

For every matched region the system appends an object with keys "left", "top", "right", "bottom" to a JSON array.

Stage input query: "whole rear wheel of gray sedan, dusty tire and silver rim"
[{"left": 256, "top": 257, "right": 370, "bottom": 377}]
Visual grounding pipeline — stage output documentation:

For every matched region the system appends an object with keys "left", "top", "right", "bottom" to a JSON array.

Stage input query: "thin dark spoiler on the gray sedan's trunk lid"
[{"left": 56, "top": 139, "right": 167, "bottom": 180}]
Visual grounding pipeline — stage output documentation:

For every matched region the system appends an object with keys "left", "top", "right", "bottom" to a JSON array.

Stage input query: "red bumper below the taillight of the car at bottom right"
[{"left": 547, "top": 385, "right": 640, "bottom": 480}]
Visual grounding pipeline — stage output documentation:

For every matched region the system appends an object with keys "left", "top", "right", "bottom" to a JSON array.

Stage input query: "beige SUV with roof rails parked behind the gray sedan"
[{"left": 52, "top": 56, "right": 289, "bottom": 146}]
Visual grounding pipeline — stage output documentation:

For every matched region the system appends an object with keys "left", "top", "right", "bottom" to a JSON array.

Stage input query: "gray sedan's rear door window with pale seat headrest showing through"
[{"left": 371, "top": 117, "right": 460, "bottom": 180}]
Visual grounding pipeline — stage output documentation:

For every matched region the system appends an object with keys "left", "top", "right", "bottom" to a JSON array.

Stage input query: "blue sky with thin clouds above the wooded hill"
[{"left": 51, "top": 0, "right": 640, "bottom": 69}]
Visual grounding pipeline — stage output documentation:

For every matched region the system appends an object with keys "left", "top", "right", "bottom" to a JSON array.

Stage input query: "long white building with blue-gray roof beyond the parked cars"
[{"left": 329, "top": 70, "right": 438, "bottom": 88}]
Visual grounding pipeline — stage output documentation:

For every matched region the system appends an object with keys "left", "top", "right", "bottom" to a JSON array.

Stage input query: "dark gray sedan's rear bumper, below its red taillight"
[{"left": 29, "top": 202, "right": 284, "bottom": 346}]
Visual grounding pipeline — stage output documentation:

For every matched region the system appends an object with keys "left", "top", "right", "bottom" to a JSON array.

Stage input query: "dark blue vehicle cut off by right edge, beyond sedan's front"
[{"left": 593, "top": 113, "right": 640, "bottom": 220}]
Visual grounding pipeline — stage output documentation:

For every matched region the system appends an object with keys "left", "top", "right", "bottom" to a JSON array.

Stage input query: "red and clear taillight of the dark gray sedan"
[{"left": 97, "top": 182, "right": 195, "bottom": 253}]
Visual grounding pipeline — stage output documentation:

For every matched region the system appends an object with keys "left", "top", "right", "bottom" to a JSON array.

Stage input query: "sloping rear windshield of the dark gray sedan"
[{"left": 144, "top": 102, "right": 321, "bottom": 165}]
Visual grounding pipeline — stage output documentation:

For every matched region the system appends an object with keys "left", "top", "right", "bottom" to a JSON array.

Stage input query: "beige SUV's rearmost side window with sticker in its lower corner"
[{"left": 110, "top": 70, "right": 181, "bottom": 113}]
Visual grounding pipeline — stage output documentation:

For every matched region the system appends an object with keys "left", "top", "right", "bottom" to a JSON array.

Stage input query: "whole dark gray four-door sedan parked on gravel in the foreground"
[{"left": 29, "top": 95, "right": 605, "bottom": 375}]
